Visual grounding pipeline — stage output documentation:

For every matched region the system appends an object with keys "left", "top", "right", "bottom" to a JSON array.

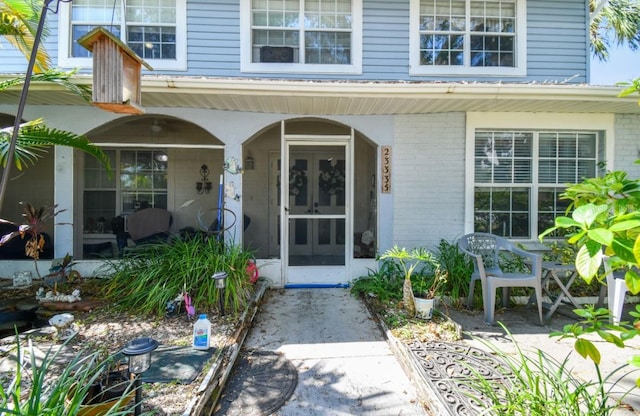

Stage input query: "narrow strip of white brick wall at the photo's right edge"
[{"left": 614, "top": 114, "right": 640, "bottom": 178}]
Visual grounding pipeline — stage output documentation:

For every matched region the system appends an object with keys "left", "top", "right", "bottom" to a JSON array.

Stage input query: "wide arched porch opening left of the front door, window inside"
[{"left": 73, "top": 114, "right": 225, "bottom": 258}]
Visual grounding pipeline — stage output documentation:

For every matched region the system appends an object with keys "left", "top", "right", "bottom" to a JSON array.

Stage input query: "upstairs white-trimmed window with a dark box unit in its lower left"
[{"left": 241, "top": 0, "right": 362, "bottom": 73}]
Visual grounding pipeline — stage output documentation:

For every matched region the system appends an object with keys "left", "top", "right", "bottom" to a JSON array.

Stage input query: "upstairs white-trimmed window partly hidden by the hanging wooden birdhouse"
[{"left": 59, "top": 0, "right": 186, "bottom": 69}]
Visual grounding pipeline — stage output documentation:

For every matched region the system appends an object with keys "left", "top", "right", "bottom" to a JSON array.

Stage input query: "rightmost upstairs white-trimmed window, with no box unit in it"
[{"left": 410, "top": 0, "right": 526, "bottom": 76}]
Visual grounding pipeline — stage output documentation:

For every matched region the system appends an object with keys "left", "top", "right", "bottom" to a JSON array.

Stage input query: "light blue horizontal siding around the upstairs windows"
[{"left": 0, "top": 0, "right": 589, "bottom": 83}]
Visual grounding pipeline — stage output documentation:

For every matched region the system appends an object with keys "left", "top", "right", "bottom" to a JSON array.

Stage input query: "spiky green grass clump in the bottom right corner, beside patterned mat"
[{"left": 464, "top": 325, "right": 631, "bottom": 416}]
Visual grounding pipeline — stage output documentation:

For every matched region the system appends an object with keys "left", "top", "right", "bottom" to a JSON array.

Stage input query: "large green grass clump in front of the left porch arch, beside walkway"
[{"left": 105, "top": 235, "right": 253, "bottom": 316}]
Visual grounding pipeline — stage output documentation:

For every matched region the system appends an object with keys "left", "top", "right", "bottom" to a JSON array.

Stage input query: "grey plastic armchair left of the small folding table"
[{"left": 458, "top": 233, "right": 544, "bottom": 325}]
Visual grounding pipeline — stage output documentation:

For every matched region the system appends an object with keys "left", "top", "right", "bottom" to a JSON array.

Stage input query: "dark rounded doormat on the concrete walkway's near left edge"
[{"left": 214, "top": 350, "right": 298, "bottom": 416}]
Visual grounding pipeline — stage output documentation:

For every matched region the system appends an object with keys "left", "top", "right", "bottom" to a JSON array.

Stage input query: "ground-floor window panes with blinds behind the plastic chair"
[{"left": 473, "top": 129, "right": 600, "bottom": 239}]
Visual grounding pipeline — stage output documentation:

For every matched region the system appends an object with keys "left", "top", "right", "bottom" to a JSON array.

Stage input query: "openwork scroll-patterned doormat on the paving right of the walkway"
[{"left": 408, "top": 341, "right": 510, "bottom": 416}]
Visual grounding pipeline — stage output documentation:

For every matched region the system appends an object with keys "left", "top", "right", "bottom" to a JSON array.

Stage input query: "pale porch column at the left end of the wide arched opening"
[{"left": 53, "top": 146, "right": 76, "bottom": 258}]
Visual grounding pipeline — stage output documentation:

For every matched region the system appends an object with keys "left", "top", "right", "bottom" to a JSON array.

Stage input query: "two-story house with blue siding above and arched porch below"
[{"left": 0, "top": 0, "right": 640, "bottom": 286}]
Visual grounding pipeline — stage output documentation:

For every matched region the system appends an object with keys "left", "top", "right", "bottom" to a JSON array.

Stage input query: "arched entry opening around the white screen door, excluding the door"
[{"left": 242, "top": 117, "right": 378, "bottom": 284}]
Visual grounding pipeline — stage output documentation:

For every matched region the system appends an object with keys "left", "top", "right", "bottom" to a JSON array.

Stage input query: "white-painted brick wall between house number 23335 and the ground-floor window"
[{"left": 390, "top": 113, "right": 465, "bottom": 249}]
